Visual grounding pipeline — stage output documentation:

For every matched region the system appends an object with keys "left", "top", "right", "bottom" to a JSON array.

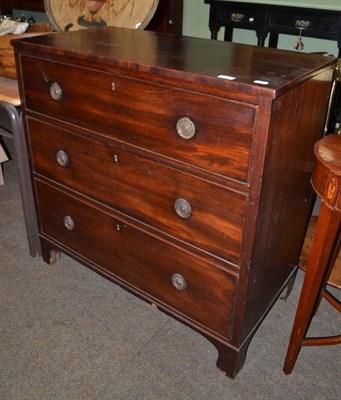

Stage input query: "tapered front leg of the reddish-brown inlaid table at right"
[{"left": 283, "top": 203, "right": 341, "bottom": 374}]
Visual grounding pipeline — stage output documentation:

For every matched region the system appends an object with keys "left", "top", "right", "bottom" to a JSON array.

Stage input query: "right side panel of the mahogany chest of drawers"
[{"left": 240, "top": 69, "right": 333, "bottom": 340}]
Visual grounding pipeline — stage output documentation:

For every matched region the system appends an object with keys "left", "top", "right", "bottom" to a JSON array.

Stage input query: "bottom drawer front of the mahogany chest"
[{"left": 36, "top": 180, "right": 235, "bottom": 337}]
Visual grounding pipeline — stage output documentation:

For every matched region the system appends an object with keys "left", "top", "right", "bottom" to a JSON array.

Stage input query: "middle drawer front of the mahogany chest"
[{"left": 28, "top": 119, "right": 246, "bottom": 263}]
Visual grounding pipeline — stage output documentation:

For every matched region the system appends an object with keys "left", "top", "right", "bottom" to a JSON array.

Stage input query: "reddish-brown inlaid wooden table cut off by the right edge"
[{"left": 283, "top": 135, "right": 341, "bottom": 374}]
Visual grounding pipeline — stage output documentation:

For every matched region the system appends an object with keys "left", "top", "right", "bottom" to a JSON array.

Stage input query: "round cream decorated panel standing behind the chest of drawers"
[{"left": 44, "top": 0, "right": 159, "bottom": 31}]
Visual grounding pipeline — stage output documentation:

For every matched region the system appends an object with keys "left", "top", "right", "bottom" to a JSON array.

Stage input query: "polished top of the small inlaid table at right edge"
[{"left": 314, "top": 135, "right": 341, "bottom": 177}]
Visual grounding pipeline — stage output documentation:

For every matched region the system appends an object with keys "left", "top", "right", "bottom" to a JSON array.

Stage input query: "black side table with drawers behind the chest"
[{"left": 205, "top": 0, "right": 341, "bottom": 57}]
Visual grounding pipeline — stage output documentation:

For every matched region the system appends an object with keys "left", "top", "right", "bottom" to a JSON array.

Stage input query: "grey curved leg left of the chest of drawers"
[{"left": 0, "top": 101, "right": 41, "bottom": 257}]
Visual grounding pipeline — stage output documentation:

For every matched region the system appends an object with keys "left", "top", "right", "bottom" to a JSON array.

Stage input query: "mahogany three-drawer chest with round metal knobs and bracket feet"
[{"left": 14, "top": 28, "right": 336, "bottom": 377}]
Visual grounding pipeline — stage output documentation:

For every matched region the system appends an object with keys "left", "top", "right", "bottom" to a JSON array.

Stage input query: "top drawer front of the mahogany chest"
[{"left": 22, "top": 56, "right": 256, "bottom": 182}]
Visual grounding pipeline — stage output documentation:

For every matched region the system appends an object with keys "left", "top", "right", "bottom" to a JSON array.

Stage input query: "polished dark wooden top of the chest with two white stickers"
[{"left": 12, "top": 27, "right": 337, "bottom": 98}]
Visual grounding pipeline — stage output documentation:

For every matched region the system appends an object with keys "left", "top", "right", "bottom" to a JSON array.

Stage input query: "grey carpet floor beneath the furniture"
[{"left": 0, "top": 138, "right": 341, "bottom": 400}]
